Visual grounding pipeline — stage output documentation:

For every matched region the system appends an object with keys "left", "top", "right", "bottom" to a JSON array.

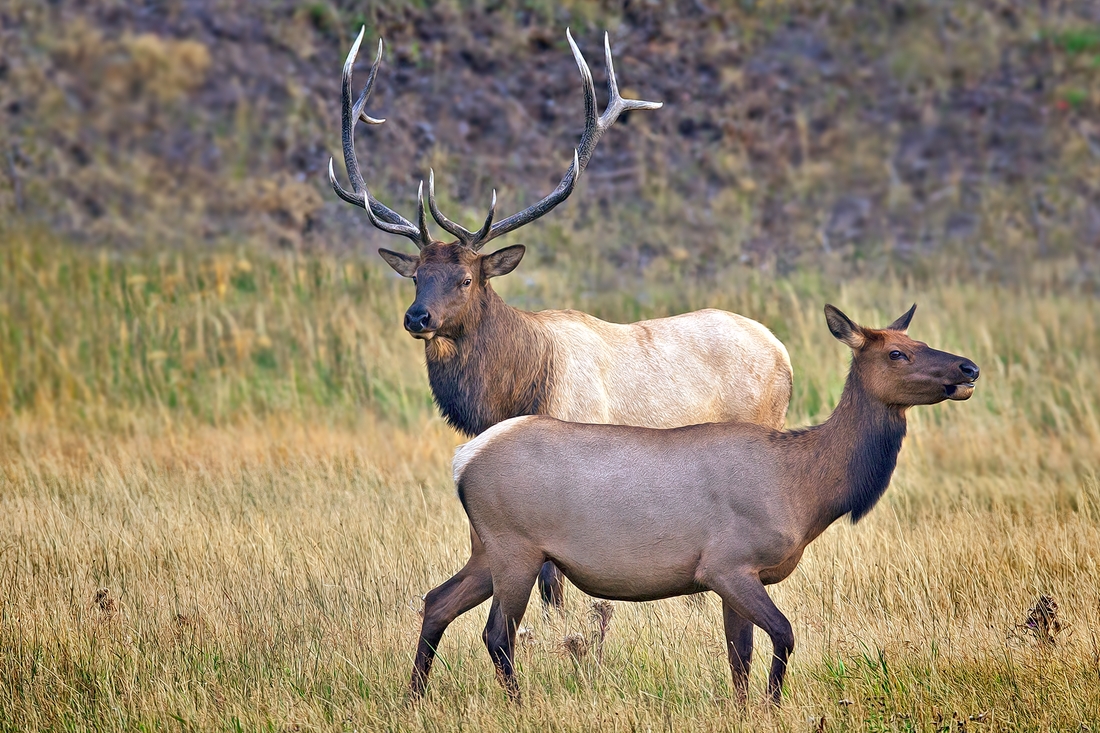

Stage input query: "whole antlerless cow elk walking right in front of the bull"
[{"left": 411, "top": 305, "right": 978, "bottom": 703}]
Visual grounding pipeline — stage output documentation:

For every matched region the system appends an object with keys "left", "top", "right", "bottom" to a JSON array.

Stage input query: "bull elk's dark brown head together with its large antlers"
[{"left": 329, "top": 29, "right": 661, "bottom": 340}]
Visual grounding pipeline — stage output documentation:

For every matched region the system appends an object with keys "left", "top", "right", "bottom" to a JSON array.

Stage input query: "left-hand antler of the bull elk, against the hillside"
[{"left": 329, "top": 26, "right": 430, "bottom": 249}]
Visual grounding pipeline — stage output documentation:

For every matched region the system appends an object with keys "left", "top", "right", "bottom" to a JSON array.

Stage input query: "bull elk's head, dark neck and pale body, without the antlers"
[{"left": 383, "top": 248, "right": 792, "bottom": 435}]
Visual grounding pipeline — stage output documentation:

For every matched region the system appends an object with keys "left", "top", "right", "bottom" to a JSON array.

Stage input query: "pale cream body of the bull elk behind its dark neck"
[{"left": 532, "top": 309, "right": 792, "bottom": 427}]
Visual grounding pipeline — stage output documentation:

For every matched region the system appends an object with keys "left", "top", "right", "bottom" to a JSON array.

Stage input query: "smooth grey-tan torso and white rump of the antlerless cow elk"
[{"left": 454, "top": 416, "right": 809, "bottom": 601}]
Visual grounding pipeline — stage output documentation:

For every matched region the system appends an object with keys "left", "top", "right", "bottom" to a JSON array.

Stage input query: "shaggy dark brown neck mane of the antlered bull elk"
[{"left": 426, "top": 283, "right": 553, "bottom": 436}]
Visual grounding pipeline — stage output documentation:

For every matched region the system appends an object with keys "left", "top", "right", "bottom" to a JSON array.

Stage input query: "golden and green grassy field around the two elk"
[{"left": 0, "top": 236, "right": 1100, "bottom": 731}]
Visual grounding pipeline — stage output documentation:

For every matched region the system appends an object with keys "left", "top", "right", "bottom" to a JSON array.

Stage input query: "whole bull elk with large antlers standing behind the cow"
[{"left": 329, "top": 31, "right": 792, "bottom": 603}]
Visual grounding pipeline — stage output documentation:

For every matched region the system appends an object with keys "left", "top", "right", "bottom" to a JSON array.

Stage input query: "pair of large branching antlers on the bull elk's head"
[{"left": 329, "top": 29, "right": 662, "bottom": 252}]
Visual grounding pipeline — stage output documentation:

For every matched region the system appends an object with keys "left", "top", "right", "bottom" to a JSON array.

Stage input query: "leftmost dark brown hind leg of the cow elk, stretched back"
[{"left": 409, "top": 528, "right": 493, "bottom": 699}]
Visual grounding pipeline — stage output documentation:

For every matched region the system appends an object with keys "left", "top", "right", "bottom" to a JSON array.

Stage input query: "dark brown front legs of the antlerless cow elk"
[{"left": 707, "top": 572, "right": 794, "bottom": 705}]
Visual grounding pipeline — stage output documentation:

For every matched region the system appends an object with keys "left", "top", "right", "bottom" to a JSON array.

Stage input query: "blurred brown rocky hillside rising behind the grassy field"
[{"left": 0, "top": 0, "right": 1100, "bottom": 284}]
